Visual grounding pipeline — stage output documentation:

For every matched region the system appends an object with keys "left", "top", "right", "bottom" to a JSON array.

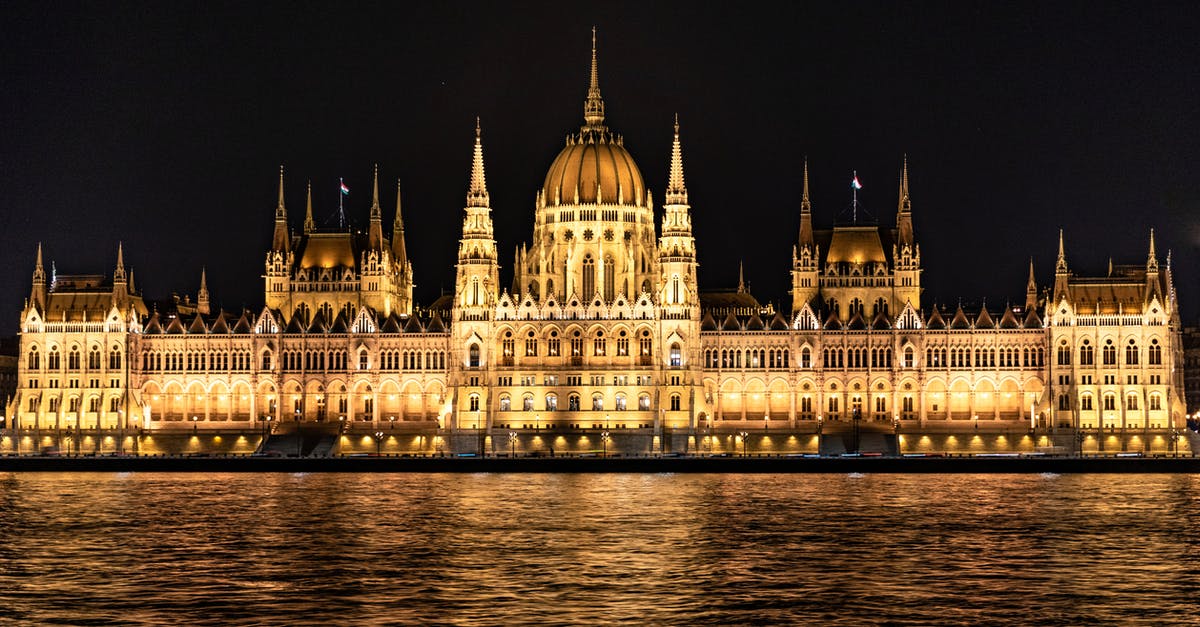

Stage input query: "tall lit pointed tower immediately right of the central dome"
[{"left": 659, "top": 115, "right": 700, "bottom": 317}]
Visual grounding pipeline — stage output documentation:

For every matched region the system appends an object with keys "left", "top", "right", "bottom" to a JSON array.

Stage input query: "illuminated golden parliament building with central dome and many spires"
[{"left": 7, "top": 35, "right": 1188, "bottom": 454}]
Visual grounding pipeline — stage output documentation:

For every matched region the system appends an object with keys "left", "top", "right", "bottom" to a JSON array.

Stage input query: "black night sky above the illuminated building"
[{"left": 0, "top": 1, "right": 1200, "bottom": 334}]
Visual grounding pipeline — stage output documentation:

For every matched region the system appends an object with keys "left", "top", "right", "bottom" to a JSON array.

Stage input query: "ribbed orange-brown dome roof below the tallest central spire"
[{"left": 542, "top": 129, "right": 646, "bottom": 207}]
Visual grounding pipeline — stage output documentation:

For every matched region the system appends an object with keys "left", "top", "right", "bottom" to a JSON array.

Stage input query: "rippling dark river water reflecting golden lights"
[{"left": 0, "top": 473, "right": 1200, "bottom": 625}]
